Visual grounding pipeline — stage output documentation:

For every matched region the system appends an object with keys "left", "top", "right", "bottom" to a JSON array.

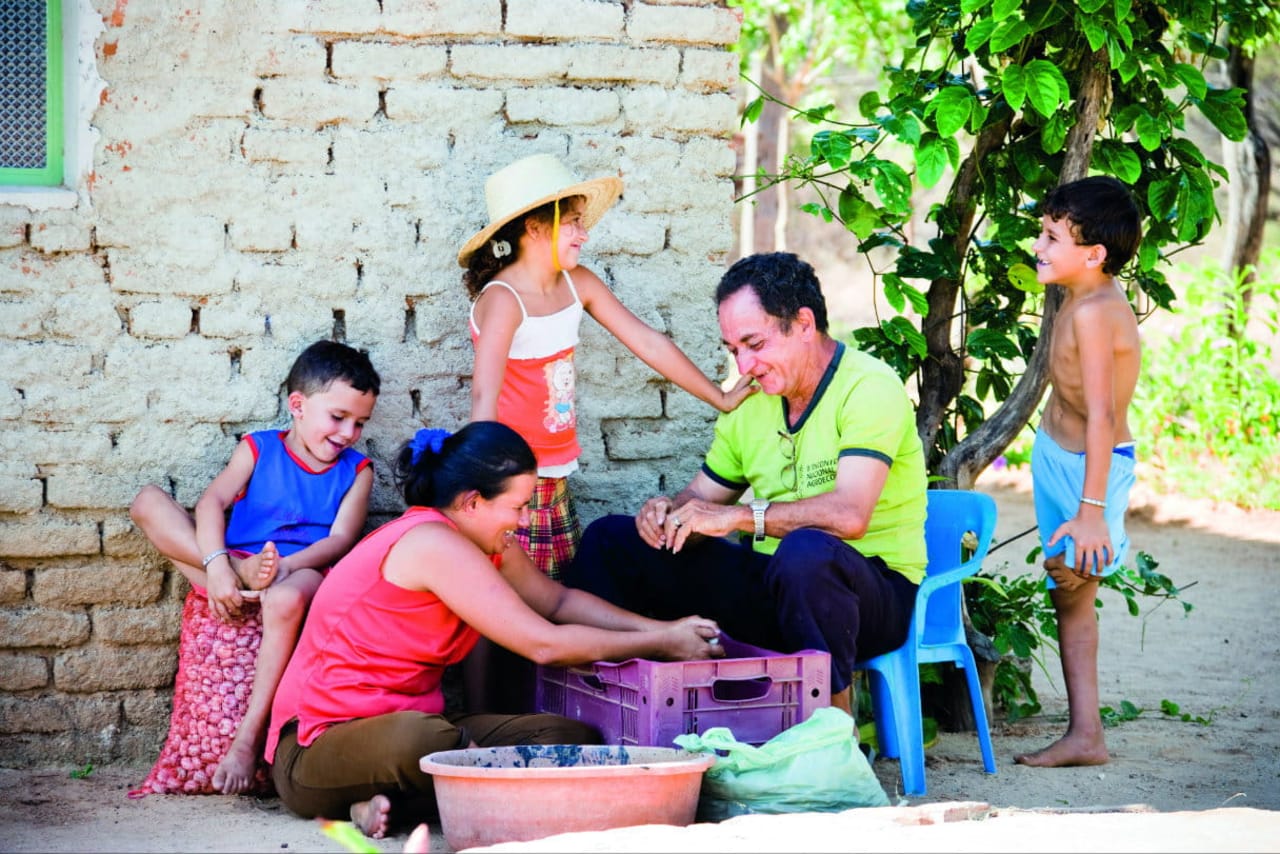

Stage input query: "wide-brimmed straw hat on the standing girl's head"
[{"left": 458, "top": 154, "right": 622, "bottom": 266}]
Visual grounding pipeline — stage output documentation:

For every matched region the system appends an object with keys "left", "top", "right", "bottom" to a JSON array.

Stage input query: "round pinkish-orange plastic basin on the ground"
[{"left": 420, "top": 744, "right": 716, "bottom": 851}]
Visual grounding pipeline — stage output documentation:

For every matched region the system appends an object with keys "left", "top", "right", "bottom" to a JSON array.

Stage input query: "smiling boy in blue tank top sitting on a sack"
[{"left": 129, "top": 341, "right": 380, "bottom": 794}]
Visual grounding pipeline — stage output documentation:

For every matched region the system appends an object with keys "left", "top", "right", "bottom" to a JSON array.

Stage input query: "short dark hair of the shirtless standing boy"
[{"left": 1041, "top": 175, "right": 1142, "bottom": 275}]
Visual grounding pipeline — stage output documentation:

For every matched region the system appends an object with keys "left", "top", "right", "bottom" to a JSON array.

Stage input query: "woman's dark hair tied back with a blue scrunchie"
[{"left": 396, "top": 421, "right": 538, "bottom": 508}]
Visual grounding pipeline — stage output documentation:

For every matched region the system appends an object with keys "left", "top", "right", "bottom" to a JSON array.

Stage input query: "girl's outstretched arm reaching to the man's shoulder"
[{"left": 572, "top": 266, "right": 756, "bottom": 412}]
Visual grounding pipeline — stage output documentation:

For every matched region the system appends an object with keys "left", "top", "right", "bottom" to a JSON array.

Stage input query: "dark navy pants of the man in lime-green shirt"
[{"left": 562, "top": 516, "right": 916, "bottom": 693}]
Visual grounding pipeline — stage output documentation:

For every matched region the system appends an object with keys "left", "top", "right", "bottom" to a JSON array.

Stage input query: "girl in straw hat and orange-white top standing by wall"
[{"left": 458, "top": 154, "right": 754, "bottom": 588}]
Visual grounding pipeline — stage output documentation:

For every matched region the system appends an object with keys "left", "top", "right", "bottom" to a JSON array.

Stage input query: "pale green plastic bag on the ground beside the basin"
[{"left": 675, "top": 707, "right": 890, "bottom": 822}]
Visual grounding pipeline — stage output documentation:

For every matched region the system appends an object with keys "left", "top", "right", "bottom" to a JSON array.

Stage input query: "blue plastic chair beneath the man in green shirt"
[{"left": 855, "top": 489, "right": 996, "bottom": 796}]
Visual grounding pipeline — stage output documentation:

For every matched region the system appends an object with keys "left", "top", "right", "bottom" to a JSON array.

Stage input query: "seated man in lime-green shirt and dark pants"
[{"left": 564, "top": 252, "right": 927, "bottom": 712}]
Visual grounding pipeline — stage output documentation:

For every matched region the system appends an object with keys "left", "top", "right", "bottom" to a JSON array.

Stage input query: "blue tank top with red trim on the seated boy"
[{"left": 227, "top": 430, "right": 371, "bottom": 558}]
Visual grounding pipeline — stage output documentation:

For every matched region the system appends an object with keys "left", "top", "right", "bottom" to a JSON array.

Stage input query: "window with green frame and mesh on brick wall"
[{"left": 0, "top": 0, "right": 64, "bottom": 187}]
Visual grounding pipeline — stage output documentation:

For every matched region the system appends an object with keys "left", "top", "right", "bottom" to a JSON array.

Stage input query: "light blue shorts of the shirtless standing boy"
[{"left": 1032, "top": 428, "right": 1134, "bottom": 589}]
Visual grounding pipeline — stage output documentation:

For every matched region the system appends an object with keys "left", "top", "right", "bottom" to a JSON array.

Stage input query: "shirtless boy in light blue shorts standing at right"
[{"left": 1015, "top": 177, "right": 1142, "bottom": 767}]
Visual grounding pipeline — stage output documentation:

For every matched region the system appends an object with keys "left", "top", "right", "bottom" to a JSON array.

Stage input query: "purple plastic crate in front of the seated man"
[{"left": 535, "top": 636, "right": 831, "bottom": 748}]
